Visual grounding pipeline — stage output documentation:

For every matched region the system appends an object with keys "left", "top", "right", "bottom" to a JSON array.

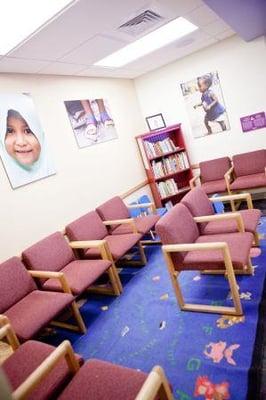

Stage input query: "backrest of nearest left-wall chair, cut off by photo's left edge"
[{"left": 0, "top": 257, "right": 37, "bottom": 313}]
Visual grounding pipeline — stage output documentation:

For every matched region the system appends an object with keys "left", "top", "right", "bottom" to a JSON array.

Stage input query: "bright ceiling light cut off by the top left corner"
[{"left": 0, "top": 0, "right": 73, "bottom": 55}]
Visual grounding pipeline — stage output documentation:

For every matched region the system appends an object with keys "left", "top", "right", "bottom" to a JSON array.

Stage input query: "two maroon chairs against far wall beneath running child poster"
[{"left": 190, "top": 149, "right": 266, "bottom": 195}]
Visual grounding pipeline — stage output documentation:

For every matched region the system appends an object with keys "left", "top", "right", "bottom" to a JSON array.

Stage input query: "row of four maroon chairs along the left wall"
[{"left": 0, "top": 196, "right": 159, "bottom": 341}]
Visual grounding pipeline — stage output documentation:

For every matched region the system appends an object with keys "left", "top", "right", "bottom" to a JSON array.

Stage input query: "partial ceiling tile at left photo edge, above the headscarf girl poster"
[{"left": 0, "top": 57, "right": 49, "bottom": 74}]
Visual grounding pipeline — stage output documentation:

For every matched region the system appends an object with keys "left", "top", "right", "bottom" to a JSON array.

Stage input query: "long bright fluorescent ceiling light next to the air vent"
[{"left": 94, "top": 17, "right": 198, "bottom": 68}]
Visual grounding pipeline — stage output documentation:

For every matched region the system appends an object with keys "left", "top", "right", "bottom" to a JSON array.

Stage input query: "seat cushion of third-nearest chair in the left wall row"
[{"left": 84, "top": 233, "right": 141, "bottom": 261}]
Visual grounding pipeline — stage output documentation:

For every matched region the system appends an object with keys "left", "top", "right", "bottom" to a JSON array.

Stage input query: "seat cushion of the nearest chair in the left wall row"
[{"left": 5, "top": 290, "right": 74, "bottom": 341}]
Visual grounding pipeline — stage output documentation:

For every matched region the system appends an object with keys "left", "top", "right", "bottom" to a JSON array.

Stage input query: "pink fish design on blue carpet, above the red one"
[{"left": 203, "top": 341, "right": 240, "bottom": 365}]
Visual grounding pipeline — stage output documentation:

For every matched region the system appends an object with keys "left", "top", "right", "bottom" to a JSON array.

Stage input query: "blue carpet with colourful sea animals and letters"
[{"left": 42, "top": 218, "right": 266, "bottom": 400}]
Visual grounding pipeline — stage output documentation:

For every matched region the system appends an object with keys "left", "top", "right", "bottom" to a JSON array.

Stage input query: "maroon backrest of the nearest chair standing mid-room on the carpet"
[{"left": 155, "top": 203, "right": 199, "bottom": 269}]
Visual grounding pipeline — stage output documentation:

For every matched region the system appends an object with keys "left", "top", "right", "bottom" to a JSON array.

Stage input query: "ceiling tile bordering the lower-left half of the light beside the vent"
[{"left": 60, "top": 35, "right": 127, "bottom": 65}]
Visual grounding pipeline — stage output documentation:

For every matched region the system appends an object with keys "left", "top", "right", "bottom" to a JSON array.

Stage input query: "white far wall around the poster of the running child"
[{"left": 135, "top": 36, "right": 266, "bottom": 163}]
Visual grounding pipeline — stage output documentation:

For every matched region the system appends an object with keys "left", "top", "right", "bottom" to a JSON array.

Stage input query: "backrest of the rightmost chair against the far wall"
[{"left": 233, "top": 149, "right": 266, "bottom": 177}]
